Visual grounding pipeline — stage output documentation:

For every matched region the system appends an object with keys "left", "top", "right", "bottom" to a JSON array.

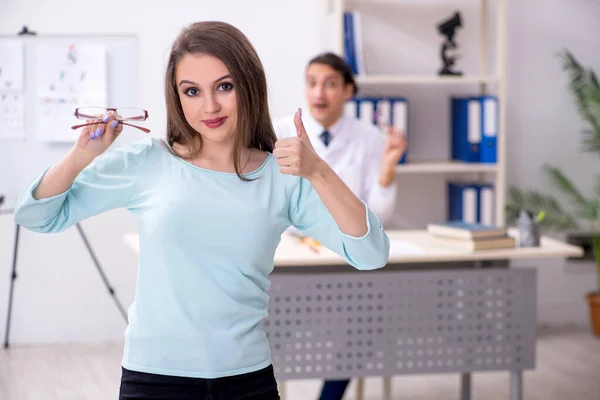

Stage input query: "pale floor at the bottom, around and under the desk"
[{"left": 0, "top": 328, "right": 600, "bottom": 400}]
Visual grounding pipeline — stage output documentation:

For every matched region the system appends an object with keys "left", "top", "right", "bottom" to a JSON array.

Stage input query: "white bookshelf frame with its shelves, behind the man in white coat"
[{"left": 327, "top": 0, "right": 506, "bottom": 225}]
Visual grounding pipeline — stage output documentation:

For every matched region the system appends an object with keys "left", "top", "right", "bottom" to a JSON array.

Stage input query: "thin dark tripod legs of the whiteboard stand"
[{"left": 0, "top": 196, "right": 127, "bottom": 349}]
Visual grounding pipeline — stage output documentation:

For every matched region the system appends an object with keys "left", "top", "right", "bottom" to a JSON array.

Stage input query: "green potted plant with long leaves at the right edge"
[{"left": 506, "top": 50, "right": 600, "bottom": 336}]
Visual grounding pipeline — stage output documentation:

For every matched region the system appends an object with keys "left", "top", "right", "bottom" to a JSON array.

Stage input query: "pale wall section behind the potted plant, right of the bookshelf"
[{"left": 507, "top": 0, "right": 600, "bottom": 330}]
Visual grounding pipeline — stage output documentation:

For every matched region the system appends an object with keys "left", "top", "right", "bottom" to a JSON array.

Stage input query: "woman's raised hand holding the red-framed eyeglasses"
[{"left": 73, "top": 112, "right": 123, "bottom": 162}]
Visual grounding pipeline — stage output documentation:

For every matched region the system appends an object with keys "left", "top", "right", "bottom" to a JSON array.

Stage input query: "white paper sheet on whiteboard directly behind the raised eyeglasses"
[{"left": 36, "top": 43, "right": 107, "bottom": 143}]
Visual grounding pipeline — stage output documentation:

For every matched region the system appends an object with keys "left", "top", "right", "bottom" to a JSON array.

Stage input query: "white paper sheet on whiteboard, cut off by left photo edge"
[{"left": 0, "top": 39, "right": 25, "bottom": 140}]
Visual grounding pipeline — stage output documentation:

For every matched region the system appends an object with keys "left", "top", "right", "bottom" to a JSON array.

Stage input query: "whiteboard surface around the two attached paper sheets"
[{"left": 0, "top": 34, "right": 140, "bottom": 198}]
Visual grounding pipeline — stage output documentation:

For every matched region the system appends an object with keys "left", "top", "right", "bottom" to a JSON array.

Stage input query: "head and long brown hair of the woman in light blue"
[{"left": 165, "top": 23, "right": 276, "bottom": 179}]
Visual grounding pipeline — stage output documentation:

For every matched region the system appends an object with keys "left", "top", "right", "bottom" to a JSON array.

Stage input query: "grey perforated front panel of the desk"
[{"left": 264, "top": 269, "right": 536, "bottom": 379}]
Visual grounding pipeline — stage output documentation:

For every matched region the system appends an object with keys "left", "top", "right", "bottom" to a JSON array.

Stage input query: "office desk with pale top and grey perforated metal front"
[{"left": 125, "top": 230, "right": 583, "bottom": 400}]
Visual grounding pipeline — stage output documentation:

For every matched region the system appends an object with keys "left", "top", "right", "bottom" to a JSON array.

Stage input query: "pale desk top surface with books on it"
[{"left": 125, "top": 229, "right": 583, "bottom": 267}]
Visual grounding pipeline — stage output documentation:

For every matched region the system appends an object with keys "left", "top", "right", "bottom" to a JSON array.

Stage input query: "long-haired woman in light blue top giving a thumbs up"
[{"left": 15, "top": 22, "right": 389, "bottom": 400}]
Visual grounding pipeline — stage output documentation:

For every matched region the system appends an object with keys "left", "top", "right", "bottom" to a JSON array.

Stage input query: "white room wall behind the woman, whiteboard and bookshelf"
[{"left": 0, "top": 0, "right": 600, "bottom": 343}]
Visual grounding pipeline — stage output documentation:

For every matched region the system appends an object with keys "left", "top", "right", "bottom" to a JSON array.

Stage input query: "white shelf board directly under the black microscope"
[{"left": 356, "top": 75, "right": 498, "bottom": 85}]
